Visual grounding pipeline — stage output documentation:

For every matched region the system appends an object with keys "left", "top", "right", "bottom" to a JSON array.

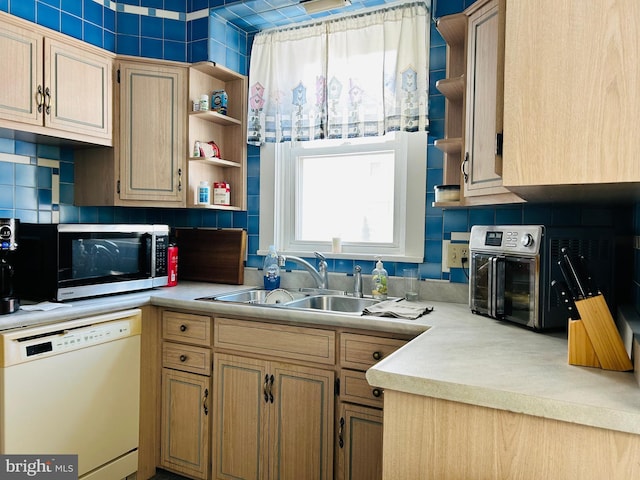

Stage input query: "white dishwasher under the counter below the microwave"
[{"left": 0, "top": 309, "right": 141, "bottom": 480}]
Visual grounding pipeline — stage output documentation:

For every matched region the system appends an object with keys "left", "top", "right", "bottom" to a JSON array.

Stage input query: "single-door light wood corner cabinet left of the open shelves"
[{"left": 75, "top": 57, "right": 187, "bottom": 207}]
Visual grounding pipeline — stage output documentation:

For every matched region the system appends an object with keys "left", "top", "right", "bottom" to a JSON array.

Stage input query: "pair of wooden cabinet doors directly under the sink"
[{"left": 213, "top": 354, "right": 335, "bottom": 480}]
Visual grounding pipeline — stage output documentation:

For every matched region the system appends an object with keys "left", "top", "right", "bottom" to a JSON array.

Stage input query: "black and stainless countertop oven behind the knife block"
[{"left": 469, "top": 225, "right": 615, "bottom": 330}]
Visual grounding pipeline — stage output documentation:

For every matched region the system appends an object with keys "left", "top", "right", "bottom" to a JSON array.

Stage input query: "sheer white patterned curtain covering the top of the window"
[{"left": 248, "top": 2, "right": 430, "bottom": 145}]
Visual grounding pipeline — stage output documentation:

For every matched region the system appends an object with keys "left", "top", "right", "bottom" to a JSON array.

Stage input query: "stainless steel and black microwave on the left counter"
[{"left": 15, "top": 223, "right": 169, "bottom": 301}]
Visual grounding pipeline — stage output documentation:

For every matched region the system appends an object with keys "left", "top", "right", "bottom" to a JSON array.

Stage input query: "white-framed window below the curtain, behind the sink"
[{"left": 260, "top": 132, "right": 427, "bottom": 262}]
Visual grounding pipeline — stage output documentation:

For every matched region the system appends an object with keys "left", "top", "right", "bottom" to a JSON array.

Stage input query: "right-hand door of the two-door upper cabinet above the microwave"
[{"left": 44, "top": 38, "right": 113, "bottom": 139}]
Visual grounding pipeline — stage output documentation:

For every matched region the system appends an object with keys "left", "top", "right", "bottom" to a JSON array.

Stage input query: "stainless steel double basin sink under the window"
[{"left": 198, "top": 288, "right": 380, "bottom": 315}]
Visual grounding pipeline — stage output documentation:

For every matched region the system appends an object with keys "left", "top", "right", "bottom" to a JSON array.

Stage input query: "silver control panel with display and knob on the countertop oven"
[{"left": 469, "top": 225, "right": 544, "bottom": 255}]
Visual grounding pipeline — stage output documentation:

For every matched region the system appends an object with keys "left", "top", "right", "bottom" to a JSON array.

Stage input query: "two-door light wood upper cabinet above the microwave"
[{"left": 0, "top": 12, "right": 113, "bottom": 145}]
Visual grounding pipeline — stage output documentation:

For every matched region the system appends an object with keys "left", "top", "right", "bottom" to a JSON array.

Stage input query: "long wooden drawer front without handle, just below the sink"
[{"left": 214, "top": 318, "right": 336, "bottom": 365}]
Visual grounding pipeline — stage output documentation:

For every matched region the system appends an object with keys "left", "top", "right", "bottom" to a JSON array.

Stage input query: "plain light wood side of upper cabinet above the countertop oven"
[{"left": 503, "top": 0, "right": 640, "bottom": 201}]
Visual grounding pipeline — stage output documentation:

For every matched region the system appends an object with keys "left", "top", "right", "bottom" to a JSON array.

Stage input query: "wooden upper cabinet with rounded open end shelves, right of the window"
[{"left": 435, "top": 0, "right": 522, "bottom": 207}]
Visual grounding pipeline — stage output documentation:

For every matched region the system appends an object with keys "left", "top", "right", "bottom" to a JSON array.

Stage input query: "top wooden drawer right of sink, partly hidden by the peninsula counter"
[{"left": 340, "top": 333, "right": 407, "bottom": 370}]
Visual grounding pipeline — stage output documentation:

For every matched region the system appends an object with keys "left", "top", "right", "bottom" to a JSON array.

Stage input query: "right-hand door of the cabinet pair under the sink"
[{"left": 270, "top": 364, "right": 335, "bottom": 480}]
